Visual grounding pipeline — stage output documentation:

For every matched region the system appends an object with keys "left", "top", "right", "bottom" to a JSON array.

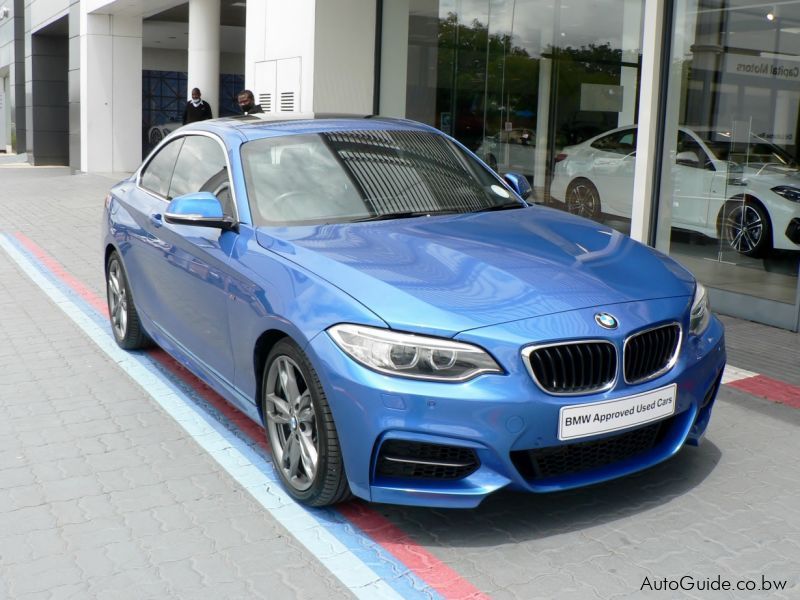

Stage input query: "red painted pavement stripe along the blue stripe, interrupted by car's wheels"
[{"left": 15, "top": 233, "right": 488, "bottom": 600}]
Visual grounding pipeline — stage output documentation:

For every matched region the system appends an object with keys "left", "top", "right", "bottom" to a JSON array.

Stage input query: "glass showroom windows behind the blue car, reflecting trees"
[{"left": 380, "top": 0, "right": 800, "bottom": 330}]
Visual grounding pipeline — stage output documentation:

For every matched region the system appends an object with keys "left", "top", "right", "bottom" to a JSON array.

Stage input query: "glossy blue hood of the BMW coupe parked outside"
[{"left": 257, "top": 207, "right": 694, "bottom": 336}]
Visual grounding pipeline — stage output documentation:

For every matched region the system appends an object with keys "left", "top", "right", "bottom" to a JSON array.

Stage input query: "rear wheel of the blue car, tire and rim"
[{"left": 106, "top": 252, "right": 151, "bottom": 350}]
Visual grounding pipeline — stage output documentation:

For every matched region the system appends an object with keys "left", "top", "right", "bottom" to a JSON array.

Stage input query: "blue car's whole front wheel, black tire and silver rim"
[{"left": 261, "top": 339, "right": 350, "bottom": 506}]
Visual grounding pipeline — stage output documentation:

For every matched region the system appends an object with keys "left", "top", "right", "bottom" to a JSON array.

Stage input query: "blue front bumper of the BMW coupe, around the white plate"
[{"left": 309, "top": 304, "right": 725, "bottom": 508}]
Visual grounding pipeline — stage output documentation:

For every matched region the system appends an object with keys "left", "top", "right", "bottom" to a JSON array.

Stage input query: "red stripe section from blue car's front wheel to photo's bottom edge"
[{"left": 336, "top": 501, "right": 489, "bottom": 600}]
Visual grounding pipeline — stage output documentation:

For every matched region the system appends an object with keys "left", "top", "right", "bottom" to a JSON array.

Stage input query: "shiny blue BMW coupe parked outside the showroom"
[{"left": 103, "top": 112, "right": 725, "bottom": 507}]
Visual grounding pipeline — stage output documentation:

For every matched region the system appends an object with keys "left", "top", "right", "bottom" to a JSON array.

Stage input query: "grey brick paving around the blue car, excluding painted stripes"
[{"left": 0, "top": 166, "right": 800, "bottom": 600}]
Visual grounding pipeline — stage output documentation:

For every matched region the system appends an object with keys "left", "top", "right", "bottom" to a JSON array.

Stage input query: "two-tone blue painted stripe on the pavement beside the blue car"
[{"left": 0, "top": 233, "right": 441, "bottom": 600}]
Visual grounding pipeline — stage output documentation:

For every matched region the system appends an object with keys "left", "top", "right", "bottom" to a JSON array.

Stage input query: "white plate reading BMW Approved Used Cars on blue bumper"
[{"left": 558, "top": 384, "right": 678, "bottom": 440}]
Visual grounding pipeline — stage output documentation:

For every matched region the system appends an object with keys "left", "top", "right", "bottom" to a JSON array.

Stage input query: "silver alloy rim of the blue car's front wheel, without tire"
[{"left": 265, "top": 355, "right": 319, "bottom": 492}]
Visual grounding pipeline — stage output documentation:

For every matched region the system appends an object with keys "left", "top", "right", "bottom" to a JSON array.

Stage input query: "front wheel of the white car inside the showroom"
[{"left": 722, "top": 198, "right": 772, "bottom": 257}]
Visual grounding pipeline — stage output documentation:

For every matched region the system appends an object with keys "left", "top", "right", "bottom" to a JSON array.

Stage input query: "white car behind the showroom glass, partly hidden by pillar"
[{"left": 550, "top": 126, "right": 800, "bottom": 256}]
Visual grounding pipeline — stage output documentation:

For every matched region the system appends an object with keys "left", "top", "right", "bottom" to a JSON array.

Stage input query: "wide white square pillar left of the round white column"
[{"left": 80, "top": 9, "right": 142, "bottom": 173}]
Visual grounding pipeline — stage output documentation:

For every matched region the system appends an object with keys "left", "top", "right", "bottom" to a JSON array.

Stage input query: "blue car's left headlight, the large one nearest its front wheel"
[{"left": 328, "top": 325, "right": 503, "bottom": 381}]
